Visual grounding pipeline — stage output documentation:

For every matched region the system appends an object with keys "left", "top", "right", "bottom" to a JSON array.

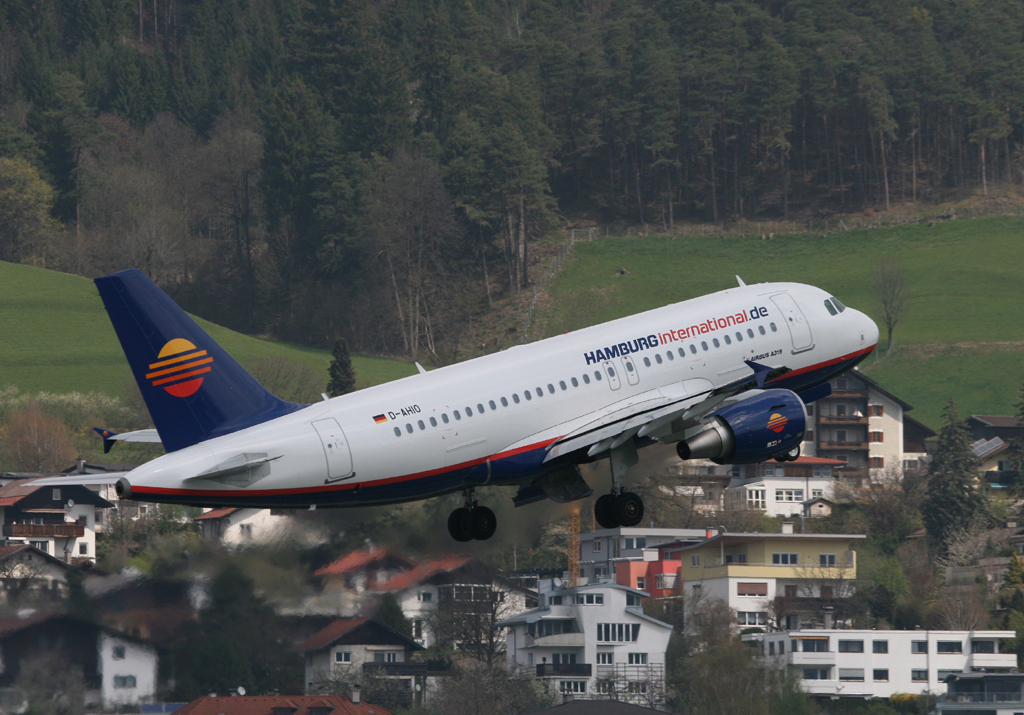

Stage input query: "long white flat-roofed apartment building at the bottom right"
[{"left": 742, "top": 629, "right": 1017, "bottom": 696}]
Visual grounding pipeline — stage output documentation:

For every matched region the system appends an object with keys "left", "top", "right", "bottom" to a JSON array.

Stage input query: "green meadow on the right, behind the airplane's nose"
[{"left": 535, "top": 212, "right": 1024, "bottom": 427}]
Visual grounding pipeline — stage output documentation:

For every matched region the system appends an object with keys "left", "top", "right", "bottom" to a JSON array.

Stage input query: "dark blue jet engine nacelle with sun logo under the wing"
[{"left": 676, "top": 389, "right": 806, "bottom": 464}]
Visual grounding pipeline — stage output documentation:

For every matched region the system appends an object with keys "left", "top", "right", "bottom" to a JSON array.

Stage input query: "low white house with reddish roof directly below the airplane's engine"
[{"left": 725, "top": 455, "right": 846, "bottom": 516}]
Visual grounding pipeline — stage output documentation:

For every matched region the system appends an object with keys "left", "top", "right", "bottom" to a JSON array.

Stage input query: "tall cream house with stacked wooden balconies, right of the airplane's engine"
[{"left": 801, "top": 370, "right": 936, "bottom": 475}]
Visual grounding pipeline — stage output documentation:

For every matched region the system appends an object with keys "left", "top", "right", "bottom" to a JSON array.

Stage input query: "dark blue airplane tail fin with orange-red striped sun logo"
[{"left": 95, "top": 270, "right": 303, "bottom": 452}]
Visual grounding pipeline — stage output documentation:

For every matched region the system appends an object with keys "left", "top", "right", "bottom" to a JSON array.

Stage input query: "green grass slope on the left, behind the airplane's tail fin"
[{"left": 0, "top": 262, "right": 416, "bottom": 395}]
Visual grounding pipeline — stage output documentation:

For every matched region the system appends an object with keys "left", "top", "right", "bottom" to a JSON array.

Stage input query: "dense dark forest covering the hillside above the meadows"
[{"left": 0, "top": 0, "right": 1024, "bottom": 361}]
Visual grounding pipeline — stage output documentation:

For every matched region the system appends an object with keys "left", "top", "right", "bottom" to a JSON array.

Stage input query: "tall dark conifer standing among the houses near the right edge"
[{"left": 922, "top": 399, "right": 985, "bottom": 551}]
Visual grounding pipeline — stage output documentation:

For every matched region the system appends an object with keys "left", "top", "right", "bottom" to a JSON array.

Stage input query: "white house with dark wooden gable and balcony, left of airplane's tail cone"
[{"left": 0, "top": 479, "right": 114, "bottom": 563}]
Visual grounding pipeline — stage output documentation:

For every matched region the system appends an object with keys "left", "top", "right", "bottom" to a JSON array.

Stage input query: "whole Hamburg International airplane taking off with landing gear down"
[{"left": 41, "top": 269, "right": 879, "bottom": 542}]
